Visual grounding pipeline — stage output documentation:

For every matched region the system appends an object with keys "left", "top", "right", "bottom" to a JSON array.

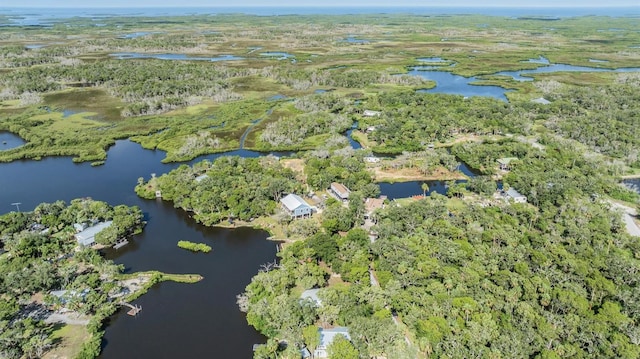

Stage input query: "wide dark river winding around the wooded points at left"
[{"left": 0, "top": 140, "right": 276, "bottom": 359}]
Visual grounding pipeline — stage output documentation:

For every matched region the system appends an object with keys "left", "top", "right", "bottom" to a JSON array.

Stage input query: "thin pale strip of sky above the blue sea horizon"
[{"left": 0, "top": 0, "right": 640, "bottom": 9}]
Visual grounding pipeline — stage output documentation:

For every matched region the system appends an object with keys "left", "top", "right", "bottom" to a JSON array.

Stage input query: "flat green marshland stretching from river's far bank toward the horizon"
[{"left": 0, "top": 14, "right": 640, "bottom": 165}]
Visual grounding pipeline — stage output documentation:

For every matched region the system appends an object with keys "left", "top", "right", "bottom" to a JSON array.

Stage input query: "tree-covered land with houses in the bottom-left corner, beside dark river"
[{"left": 0, "top": 199, "right": 143, "bottom": 358}]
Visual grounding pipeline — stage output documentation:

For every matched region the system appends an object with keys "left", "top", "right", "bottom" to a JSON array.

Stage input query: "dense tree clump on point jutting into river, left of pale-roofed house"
[{"left": 136, "top": 157, "right": 299, "bottom": 225}]
